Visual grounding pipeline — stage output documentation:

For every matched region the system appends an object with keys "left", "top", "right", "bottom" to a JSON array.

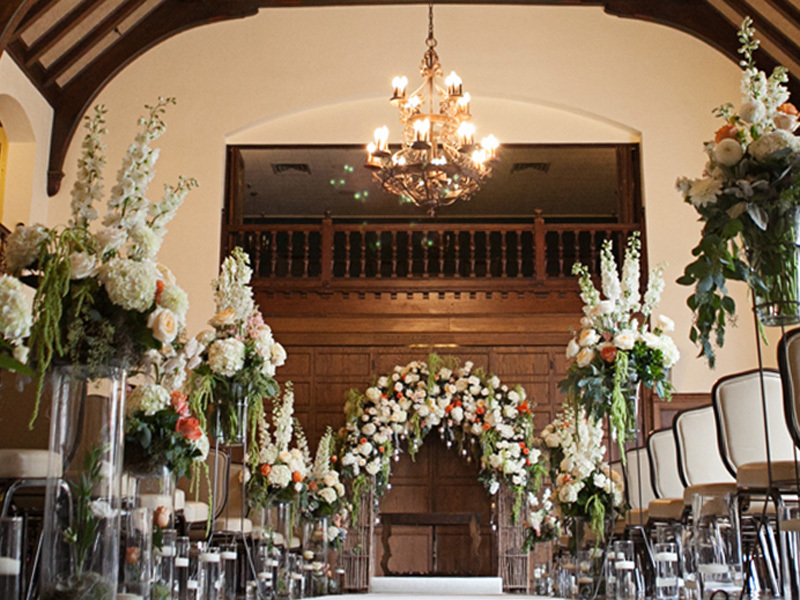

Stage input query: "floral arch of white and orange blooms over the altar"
[{"left": 339, "top": 354, "right": 546, "bottom": 517}]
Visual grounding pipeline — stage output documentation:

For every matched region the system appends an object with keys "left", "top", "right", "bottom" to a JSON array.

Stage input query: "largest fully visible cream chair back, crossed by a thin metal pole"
[{"left": 711, "top": 369, "right": 794, "bottom": 477}]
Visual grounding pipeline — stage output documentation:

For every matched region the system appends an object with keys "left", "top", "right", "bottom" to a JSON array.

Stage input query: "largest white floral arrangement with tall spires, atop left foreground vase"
[{"left": 5, "top": 98, "right": 197, "bottom": 417}]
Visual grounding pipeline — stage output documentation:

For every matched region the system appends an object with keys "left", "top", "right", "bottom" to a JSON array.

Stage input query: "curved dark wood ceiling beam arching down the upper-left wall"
[{"left": 47, "top": 0, "right": 260, "bottom": 196}]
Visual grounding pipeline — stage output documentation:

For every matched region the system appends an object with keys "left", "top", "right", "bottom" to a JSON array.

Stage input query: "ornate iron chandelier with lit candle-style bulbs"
[{"left": 366, "top": 3, "right": 500, "bottom": 216}]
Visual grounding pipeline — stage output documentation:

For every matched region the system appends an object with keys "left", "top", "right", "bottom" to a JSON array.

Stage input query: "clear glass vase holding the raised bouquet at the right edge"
[{"left": 743, "top": 208, "right": 800, "bottom": 327}]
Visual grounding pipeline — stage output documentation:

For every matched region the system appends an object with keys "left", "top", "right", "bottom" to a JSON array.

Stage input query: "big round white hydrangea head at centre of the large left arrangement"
[{"left": 101, "top": 257, "right": 159, "bottom": 312}]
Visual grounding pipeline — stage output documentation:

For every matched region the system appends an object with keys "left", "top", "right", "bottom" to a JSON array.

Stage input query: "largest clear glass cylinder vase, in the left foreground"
[{"left": 40, "top": 365, "right": 125, "bottom": 600}]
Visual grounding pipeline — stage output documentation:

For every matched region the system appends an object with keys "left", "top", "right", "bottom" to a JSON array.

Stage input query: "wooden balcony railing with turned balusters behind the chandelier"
[{"left": 223, "top": 217, "right": 640, "bottom": 288}]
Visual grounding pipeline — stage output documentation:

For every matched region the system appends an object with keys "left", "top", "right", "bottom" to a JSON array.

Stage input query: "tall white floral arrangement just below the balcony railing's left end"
[{"left": 189, "top": 248, "right": 286, "bottom": 442}]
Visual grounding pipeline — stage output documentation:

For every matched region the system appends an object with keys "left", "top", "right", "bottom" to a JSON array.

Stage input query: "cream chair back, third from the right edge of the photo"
[{"left": 672, "top": 404, "right": 736, "bottom": 487}]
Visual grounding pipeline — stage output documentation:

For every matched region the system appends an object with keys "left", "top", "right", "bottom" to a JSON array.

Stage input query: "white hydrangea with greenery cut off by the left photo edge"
[{"left": 0, "top": 274, "right": 33, "bottom": 373}]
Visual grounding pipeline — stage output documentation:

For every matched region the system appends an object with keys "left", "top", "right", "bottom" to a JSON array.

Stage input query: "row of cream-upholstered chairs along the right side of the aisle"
[{"left": 626, "top": 329, "right": 800, "bottom": 596}]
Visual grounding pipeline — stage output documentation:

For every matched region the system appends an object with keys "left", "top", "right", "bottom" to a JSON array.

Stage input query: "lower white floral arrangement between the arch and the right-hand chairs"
[{"left": 541, "top": 405, "right": 625, "bottom": 540}]
